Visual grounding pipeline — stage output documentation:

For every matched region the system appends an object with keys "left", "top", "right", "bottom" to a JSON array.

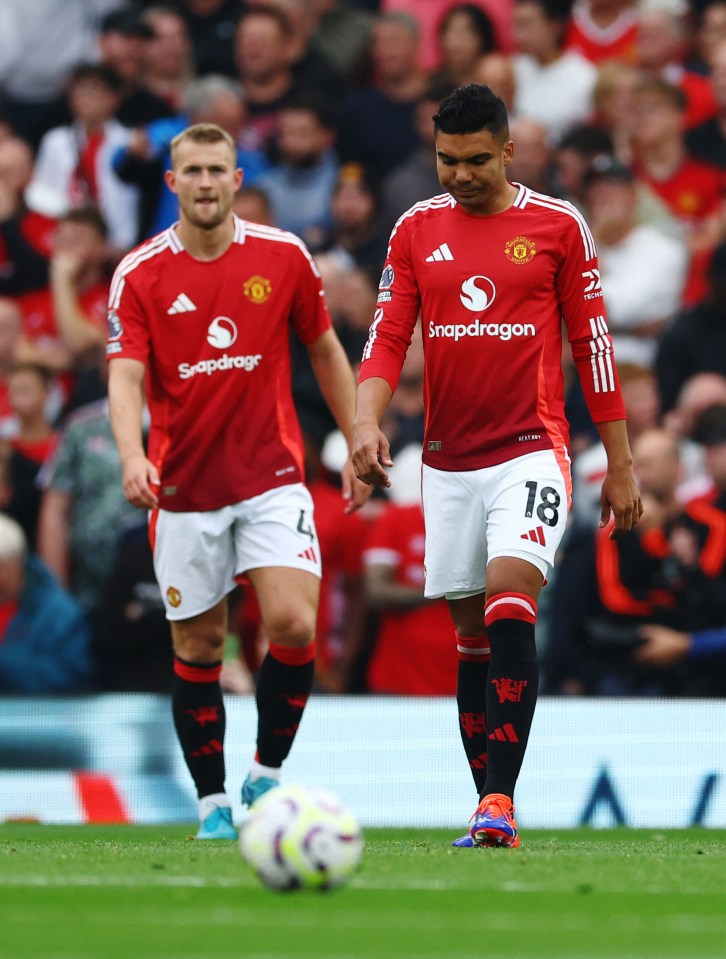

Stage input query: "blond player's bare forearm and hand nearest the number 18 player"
[{"left": 308, "top": 329, "right": 372, "bottom": 513}]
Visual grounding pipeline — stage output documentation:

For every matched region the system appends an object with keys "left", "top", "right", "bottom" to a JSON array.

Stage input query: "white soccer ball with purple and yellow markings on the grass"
[{"left": 240, "top": 786, "right": 363, "bottom": 892}]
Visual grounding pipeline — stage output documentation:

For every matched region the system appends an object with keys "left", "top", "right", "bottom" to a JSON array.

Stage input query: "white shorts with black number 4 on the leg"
[{"left": 150, "top": 483, "right": 321, "bottom": 620}]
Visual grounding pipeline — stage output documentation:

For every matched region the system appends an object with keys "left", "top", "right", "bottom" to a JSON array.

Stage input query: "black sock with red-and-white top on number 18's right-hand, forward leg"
[{"left": 484, "top": 593, "right": 539, "bottom": 799}]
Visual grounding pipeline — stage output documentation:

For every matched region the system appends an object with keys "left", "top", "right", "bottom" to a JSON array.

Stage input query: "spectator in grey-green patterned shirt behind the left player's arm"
[{"left": 38, "top": 400, "right": 139, "bottom": 626}]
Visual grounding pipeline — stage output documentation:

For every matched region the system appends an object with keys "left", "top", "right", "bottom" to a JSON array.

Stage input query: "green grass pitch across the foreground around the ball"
[{"left": 0, "top": 824, "right": 726, "bottom": 959}]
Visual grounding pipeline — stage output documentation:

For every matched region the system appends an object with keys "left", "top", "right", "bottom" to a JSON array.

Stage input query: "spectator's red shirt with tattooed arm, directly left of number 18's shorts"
[{"left": 363, "top": 503, "right": 458, "bottom": 696}]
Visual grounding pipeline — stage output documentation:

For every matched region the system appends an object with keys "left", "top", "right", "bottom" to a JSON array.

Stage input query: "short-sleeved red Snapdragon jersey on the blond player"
[{"left": 106, "top": 217, "right": 331, "bottom": 512}]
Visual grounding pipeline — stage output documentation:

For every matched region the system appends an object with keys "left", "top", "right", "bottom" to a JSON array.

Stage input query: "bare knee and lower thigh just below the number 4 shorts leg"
[{"left": 247, "top": 566, "right": 320, "bottom": 646}]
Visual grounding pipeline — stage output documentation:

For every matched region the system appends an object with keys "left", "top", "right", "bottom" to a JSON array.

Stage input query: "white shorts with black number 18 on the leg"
[{"left": 422, "top": 448, "right": 572, "bottom": 599}]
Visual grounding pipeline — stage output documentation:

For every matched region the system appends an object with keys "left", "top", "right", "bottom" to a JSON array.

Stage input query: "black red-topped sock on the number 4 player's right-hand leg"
[{"left": 256, "top": 643, "right": 315, "bottom": 767}]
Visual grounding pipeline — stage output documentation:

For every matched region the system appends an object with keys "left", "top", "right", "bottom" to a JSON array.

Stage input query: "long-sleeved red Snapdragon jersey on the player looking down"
[{"left": 359, "top": 186, "right": 625, "bottom": 471}]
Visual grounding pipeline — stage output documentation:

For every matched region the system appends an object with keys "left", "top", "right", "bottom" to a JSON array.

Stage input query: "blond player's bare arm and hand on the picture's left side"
[{"left": 108, "top": 357, "right": 159, "bottom": 509}]
